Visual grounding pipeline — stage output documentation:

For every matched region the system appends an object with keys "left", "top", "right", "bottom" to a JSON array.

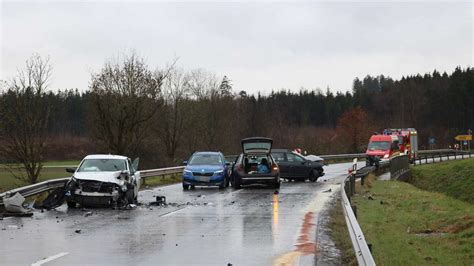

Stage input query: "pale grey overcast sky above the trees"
[{"left": 0, "top": 1, "right": 474, "bottom": 94}]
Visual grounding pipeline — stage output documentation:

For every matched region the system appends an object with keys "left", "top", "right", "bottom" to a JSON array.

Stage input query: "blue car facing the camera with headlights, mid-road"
[{"left": 183, "top": 151, "right": 229, "bottom": 190}]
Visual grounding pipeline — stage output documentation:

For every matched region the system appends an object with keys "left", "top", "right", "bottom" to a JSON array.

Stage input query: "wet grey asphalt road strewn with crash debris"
[{"left": 0, "top": 163, "right": 362, "bottom": 265}]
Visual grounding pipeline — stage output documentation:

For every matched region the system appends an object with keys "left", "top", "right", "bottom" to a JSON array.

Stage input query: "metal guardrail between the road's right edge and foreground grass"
[{"left": 341, "top": 159, "right": 375, "bottom": 265}]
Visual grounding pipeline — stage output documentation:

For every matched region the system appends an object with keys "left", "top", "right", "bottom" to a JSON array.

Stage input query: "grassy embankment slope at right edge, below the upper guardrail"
[{"left": 408, "top": 158, "right": 474, "bottom": 203}]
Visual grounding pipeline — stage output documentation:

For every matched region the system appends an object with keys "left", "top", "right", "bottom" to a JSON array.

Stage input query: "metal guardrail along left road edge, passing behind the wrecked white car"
[{"left": 0, "top": 166, "right": 184, "bottom": 206}]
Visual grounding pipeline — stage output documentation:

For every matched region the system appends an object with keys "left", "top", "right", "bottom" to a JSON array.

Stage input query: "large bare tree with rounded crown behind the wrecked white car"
[{"left": 90, "top": 53, "right": 173, "bottom": 154}]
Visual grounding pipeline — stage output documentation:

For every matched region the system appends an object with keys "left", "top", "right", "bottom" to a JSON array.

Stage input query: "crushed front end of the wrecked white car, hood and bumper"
[{"left": 65, "top": 172, "right": 134, "bottom": 207}]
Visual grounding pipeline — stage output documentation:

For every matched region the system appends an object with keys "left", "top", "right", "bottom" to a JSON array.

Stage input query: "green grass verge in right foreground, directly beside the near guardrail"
[{"left": 353, "top": 181, "right": 474, "bottom": 265}]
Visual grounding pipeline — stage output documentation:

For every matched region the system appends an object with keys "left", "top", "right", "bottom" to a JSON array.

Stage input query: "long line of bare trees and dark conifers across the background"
[{"left": 0, "top": 54, "right": 474, "bottom": 182}]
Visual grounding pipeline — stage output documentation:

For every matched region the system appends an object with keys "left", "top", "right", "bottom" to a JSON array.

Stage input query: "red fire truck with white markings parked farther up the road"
[{"left": 366, "top": 128, "right": 418, "bottom": 165}]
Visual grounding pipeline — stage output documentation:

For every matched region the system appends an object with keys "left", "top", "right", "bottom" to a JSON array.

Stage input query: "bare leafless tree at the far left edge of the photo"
[{"left": 0, "top": 55, "right": 52, "bottom": 184}]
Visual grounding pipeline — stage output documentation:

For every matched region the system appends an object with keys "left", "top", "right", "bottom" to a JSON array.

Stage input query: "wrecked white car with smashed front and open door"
[{"left": 65, "top": 154, "right": 141, "bottom": 207}]
